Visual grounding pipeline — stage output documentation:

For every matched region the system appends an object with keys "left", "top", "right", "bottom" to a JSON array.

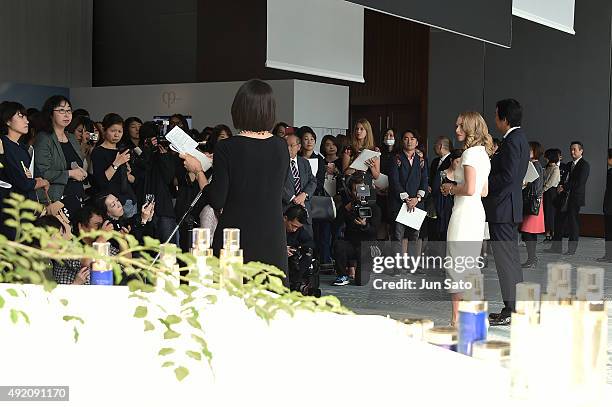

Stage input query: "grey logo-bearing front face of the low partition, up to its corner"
[{"left": 70, "top": 80, "right": 293, "bottom": 130}]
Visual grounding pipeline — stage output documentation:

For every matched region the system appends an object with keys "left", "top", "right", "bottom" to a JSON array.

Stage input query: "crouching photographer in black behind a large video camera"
[{"left": 332, "top": 174, "right": 381, "bottom": 286}]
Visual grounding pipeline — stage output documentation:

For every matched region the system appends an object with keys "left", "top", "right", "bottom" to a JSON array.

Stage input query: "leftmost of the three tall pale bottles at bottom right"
[{"left": 510, "top": 282, "right": 541, "bottom": 399}]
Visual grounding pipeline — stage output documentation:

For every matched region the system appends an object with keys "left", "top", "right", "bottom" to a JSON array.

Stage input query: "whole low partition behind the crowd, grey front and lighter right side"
[{"left": 70, "top": 80, "right": 349, "bottom": 134}]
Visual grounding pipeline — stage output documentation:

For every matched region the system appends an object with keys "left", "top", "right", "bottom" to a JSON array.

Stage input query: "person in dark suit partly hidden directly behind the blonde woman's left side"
[{"left": 426, "top": 136, "right": 453, "bottom": 242}]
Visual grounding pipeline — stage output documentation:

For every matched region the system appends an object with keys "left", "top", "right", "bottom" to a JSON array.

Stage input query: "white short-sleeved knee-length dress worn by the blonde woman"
[{"left": 446, "top": 146, "right": 491, "bottom": 292}]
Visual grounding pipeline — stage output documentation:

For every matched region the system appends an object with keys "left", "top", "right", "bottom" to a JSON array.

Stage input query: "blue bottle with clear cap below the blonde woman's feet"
[{"left": 457, "top": 274, "right": 488, "bottom": 356}]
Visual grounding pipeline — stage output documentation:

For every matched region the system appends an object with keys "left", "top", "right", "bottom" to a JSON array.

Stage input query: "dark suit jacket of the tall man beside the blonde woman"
[{"left": 483, "top": 128, "right": 529, "bottom": 223}]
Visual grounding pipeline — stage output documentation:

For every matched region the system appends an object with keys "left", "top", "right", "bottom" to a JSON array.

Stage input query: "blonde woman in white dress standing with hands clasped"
[{"left": 440, "top": 112, "right": 493, "bottom": 325}]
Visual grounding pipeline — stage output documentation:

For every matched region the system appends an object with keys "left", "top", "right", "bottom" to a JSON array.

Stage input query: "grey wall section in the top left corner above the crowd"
[{"left": 0, "top": 0, "right": 93, "bottom": 87}]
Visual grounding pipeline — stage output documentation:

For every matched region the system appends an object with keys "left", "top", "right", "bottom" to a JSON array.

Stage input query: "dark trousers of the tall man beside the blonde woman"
[{"left": 489, "top": 223, "right": 523, "bottom": 311}]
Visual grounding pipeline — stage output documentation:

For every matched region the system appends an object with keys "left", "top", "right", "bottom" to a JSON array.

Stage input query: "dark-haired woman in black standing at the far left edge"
[{"left": 0, "top": 102, "right": 49, "bottom": 201}]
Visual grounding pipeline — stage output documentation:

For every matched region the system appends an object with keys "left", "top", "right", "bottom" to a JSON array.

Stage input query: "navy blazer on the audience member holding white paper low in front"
[{"left": 388, "top": 151, "right": 429, "bottom": 219}]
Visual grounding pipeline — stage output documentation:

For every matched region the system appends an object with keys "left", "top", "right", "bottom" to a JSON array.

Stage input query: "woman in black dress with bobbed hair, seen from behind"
[{"left": 182, "top": 79, "right": 289, "bottom": 274}]
